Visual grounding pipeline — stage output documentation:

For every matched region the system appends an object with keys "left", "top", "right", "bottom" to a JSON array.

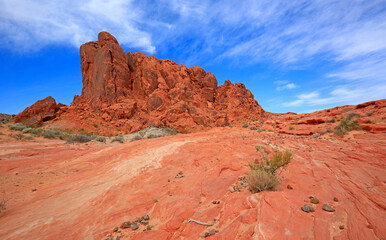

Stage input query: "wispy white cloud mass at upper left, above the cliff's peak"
[{"left": 0, "top": 0, "right": 155, "bottom": 53}]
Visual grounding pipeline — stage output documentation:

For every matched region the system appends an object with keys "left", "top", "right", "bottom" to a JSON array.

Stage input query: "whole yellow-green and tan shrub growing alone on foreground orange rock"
[{"left": 247, "top": 145, "right": 292, "bottom": 193}]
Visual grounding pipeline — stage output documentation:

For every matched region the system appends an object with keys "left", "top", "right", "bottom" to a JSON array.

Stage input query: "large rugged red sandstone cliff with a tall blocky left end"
[{"left": 25, "top": 32, "right": 265, "bottom": 135}]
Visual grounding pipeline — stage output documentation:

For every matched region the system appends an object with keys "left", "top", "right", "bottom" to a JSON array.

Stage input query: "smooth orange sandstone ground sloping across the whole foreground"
[{"left": 0, "top": 119, "right": 386, "bottom": 239}]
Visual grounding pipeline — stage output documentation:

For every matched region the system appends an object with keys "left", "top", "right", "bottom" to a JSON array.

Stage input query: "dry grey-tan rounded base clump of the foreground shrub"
[{"left": 247, "top": 170, "right": 280, "bottom": 193}]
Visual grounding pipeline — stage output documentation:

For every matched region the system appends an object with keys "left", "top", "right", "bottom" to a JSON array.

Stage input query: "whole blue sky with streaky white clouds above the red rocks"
[{"left": 0, "top": 0, "right": 386, "bottom": 113}]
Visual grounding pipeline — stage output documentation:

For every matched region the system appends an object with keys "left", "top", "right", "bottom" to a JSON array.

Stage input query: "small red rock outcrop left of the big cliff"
[{"left": 14, "top": 96, "right": 58, "bottom": 125}]
